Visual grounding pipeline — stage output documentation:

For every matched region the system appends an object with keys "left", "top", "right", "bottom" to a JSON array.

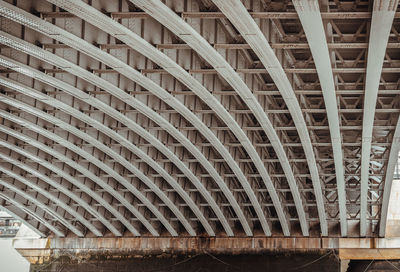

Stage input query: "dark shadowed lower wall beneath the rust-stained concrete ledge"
[{"left": 31, "top": 251, "right": 339, "bottom": 272}]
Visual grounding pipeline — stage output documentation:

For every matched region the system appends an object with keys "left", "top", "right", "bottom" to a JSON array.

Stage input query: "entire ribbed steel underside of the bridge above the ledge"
[{"left": 0, "top": 0, "right": 400, "bottom": 236}]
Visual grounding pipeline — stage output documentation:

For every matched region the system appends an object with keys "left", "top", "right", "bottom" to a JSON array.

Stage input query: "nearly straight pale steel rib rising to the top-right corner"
[{"left": 360, "top": 0, "right": 398, "bottom": 236}]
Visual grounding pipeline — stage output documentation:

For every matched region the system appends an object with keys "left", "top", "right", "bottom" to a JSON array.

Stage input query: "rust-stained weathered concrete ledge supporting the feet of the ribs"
[{"left": 14, "top": 237, "right": 400, "bottom": 264}]
